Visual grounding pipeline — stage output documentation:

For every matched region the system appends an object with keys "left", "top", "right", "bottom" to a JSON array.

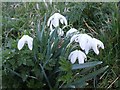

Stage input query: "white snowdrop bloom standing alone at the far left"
[{"left": 17, "top": 35, "right": 33, "bottom": 50}]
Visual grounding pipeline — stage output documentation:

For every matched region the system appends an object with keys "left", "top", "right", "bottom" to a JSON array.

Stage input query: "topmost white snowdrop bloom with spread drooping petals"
[{"left": 47, "top": 13, "right": 67, "bottom": 30}]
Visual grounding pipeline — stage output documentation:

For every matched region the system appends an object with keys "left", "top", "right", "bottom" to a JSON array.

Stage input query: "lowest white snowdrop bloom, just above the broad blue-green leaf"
[{"left": 68, "top": 50, "right": 87, "bottom": 64}]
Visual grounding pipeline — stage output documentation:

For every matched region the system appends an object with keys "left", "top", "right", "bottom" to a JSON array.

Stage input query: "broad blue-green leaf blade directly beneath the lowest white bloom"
[{"left": 72, "top": 61, "right": 102, "bottom": 70}]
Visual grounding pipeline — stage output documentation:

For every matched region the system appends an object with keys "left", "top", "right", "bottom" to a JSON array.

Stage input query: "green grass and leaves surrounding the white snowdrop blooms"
[{"left": 2, "top": 2, "right": 120, "bottom": 89}]
